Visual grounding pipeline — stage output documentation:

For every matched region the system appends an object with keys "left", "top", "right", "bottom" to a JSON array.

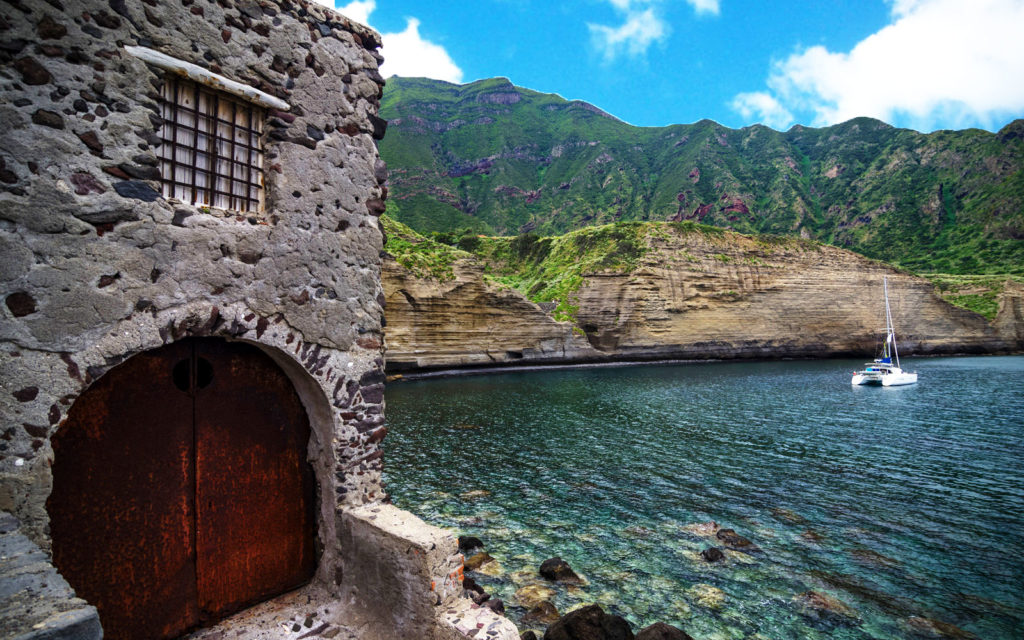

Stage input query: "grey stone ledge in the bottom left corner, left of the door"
[{"left": 0, "top": 511, "right": 103, "bottom": 640}]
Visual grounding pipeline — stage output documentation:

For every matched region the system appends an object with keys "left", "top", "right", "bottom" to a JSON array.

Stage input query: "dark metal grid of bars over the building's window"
[{"left": 159, "top": 74, "right": 264, "bottom": 212}]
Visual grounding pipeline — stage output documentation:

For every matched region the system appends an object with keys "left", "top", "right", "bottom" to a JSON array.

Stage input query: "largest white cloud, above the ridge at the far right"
[{"left": 732, "top": 0, "right": 1024, "bottom": 131}]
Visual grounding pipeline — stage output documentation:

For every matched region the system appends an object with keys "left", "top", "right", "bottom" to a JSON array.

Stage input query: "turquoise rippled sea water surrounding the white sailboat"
[{"left": 385, "top": 356, "right": 1024, "bottom": 640}]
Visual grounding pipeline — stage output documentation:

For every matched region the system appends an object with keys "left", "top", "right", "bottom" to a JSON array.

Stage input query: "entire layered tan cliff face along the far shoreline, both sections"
[{"left": 384, "top": 225, "right": 1024, "bottom": 371}]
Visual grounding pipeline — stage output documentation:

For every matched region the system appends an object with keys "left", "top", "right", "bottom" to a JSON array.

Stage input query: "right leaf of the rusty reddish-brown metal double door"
[{"left": 196, "top": 342, "right": 314, "bottom": 620}]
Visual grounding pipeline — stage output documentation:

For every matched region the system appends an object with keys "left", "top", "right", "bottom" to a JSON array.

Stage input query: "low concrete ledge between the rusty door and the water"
[{"left": 338, "top": 504, "right": 519, "bottom": 640}]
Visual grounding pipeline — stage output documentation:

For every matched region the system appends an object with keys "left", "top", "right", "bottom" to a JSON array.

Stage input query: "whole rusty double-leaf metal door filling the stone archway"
[{"left": 47, "top": 339, "right": 315, "bottom": 640}]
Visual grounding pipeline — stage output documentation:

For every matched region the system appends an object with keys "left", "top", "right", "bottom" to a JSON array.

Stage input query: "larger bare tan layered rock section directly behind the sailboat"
[{"left": 577, "top": 229, "right": 1021, "bottom": 357}]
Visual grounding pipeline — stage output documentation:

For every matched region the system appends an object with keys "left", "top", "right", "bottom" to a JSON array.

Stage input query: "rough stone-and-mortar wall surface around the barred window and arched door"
[{"left": 0, "top": 0, "right": 512, "bottom": 637}]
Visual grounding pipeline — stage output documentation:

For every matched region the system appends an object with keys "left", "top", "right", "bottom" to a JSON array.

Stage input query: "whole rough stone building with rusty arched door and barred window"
[{"left": 0, "top": 0, "right": 516, "bottom": 638}]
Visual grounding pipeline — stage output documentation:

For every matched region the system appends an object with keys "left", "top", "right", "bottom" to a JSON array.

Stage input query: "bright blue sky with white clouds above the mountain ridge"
[{"left": 321, "top": 0, "right": 1024, "bottom": 131}]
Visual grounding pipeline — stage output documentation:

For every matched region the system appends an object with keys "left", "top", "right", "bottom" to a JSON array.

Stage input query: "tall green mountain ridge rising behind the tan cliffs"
[{"left": 380, "top": 78, "right": 1024, "bottom": 273}]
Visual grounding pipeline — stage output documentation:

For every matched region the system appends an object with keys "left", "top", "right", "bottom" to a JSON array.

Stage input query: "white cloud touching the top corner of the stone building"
[{"left": 316, "top": 0, "right": 463, "bottom": 83}]
